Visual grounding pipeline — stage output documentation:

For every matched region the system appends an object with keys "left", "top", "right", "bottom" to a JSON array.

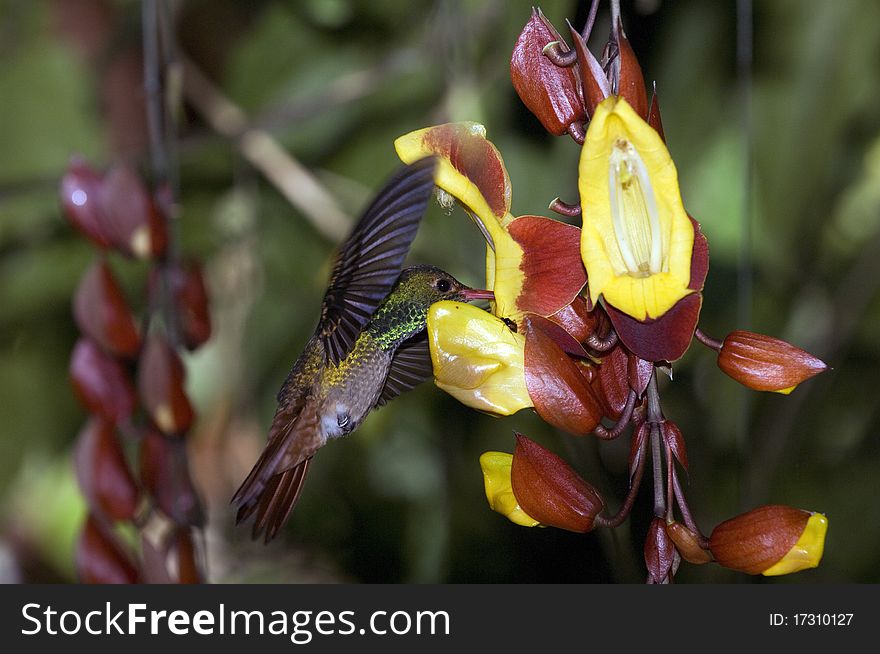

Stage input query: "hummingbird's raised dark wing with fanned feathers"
[{"left": 317, "top": 158, "right": 436, "bottom": 365}]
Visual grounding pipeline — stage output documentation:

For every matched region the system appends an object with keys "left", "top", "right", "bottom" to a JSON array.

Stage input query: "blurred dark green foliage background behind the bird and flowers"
[{"left": 0, "top": 0, "right": 880, "bottom": 583}]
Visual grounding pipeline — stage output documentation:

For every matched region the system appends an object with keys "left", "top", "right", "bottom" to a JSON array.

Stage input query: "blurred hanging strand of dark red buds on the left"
[{"left": 60, "top": 160, "right": 211, "bottom": 583}]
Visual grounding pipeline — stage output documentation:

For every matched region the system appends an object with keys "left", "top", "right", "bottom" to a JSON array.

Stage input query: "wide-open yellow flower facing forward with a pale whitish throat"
[{"left": 578, "top": 96, "right": 694, "bottom": 321}]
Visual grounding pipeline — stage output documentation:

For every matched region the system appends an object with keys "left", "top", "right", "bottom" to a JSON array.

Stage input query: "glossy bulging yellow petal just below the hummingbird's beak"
[{"left": 428, "top": 300, "right": 532, "bottom": 415}]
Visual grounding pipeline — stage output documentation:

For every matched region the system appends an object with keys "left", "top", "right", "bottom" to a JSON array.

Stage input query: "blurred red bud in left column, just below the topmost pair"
[{"left": 73, "top": 261, "right": 141, "bottom": 357}]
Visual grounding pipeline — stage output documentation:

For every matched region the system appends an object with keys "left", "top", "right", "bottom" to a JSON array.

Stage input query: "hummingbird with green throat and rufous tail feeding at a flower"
[{"left": 232, "top": 157, "right": 493, "bottom": 543}]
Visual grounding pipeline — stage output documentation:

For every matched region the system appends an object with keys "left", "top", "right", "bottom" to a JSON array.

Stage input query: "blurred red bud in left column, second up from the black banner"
[{"left": 74, "top": 418, "right": 139, "bottom": 520}]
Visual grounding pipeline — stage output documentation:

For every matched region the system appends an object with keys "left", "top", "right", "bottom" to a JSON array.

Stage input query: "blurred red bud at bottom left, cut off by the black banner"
[{"left": 75, "top": 515, "right": 138, "bottom": 584}]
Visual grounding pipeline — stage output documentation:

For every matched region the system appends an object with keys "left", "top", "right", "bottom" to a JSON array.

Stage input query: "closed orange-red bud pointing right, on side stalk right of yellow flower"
[{"left": 718, "top": 330, "right": 828, "bottom": 395}]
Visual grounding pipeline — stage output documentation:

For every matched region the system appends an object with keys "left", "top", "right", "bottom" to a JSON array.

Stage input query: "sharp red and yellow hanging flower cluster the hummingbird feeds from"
[{"left": 395, "top": 0, "right": 827, "bottom": 583}]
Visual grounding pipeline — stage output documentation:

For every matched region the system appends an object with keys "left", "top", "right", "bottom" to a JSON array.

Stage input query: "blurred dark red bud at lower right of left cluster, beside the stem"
[{"left": 140, "top": 431, "right": 204, "bottom": 527}]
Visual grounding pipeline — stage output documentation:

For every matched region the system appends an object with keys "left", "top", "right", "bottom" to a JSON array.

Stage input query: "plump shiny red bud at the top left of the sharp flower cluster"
[{"left": 510, "top": 8, "right": 586, "bottom": 136}]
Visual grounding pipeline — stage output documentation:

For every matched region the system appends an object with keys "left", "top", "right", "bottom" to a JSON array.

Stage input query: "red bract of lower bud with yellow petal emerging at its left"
[{"left": 510, "top": 434, "right": 604, "bottom": 533}]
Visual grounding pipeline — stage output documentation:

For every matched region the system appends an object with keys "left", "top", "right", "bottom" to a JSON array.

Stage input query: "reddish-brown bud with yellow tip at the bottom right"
[{"left": 709, "top": 505, "right": 828, "bottom": 576}]
